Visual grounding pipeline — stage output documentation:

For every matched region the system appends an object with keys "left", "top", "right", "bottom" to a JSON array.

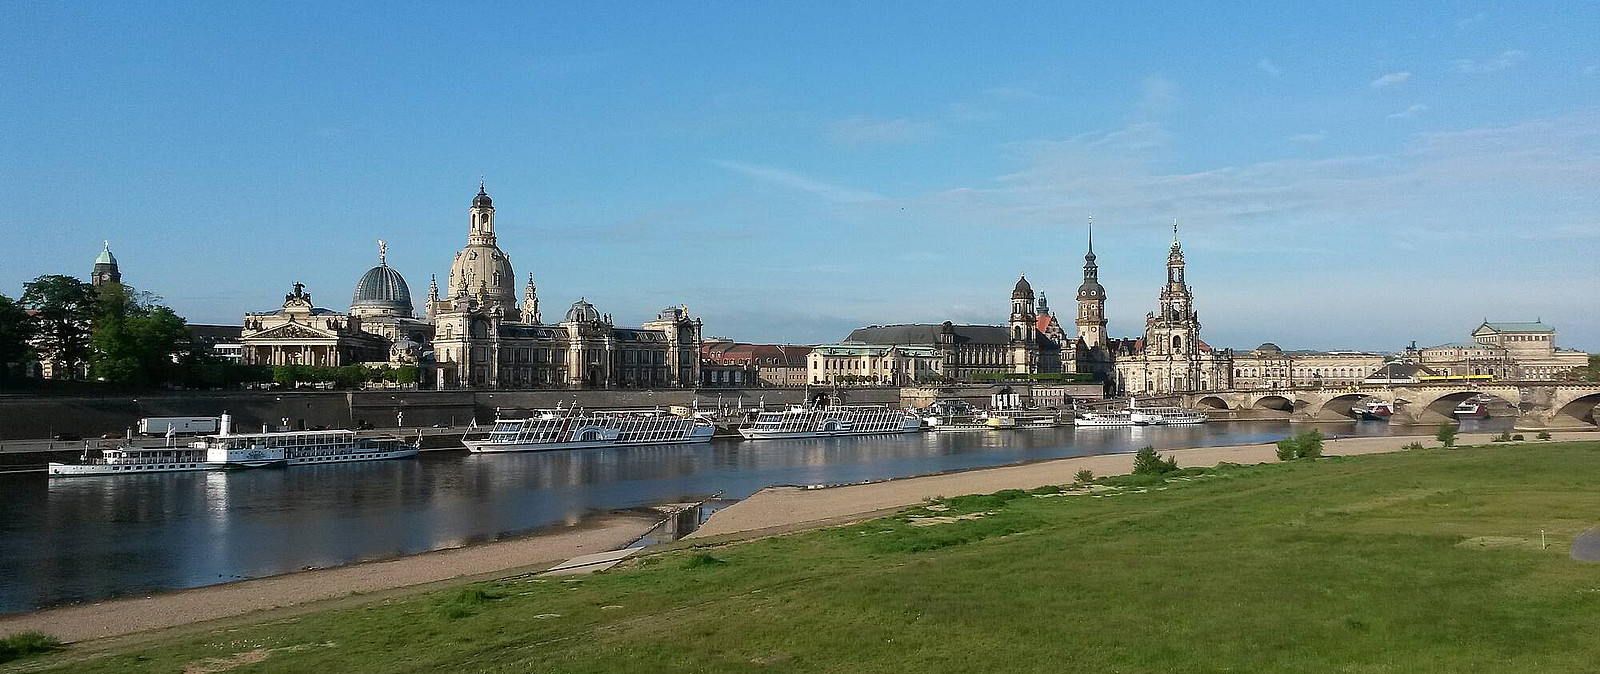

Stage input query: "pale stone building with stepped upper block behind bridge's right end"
[{"left": 1408, "top": 320, "right": 1589, "bottom": 381}]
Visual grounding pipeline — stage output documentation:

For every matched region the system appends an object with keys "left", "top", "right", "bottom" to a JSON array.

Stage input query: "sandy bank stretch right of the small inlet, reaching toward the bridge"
[{"left": 688, "top": 432, "right": 1600, "bottom": 538}]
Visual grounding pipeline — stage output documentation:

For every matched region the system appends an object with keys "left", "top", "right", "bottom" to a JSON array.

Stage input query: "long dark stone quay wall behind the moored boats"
[{"left": 0, "top": 387, "right": 899, "bottom": 440}]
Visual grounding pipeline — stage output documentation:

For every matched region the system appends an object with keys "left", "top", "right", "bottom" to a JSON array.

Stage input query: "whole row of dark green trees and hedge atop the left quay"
[{"left": 0, "top": 274, "right": 419, "bottom": 389}]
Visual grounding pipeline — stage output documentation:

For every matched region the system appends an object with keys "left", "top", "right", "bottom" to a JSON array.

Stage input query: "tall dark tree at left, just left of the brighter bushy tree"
[{"left": 21, "top": 274, "right": 98, "bottom": 378}]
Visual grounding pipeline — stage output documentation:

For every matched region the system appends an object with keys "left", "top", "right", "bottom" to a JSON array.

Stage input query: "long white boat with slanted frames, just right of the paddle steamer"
[{"left": 461, "top": 408, "right": 715, "bottom": 453}]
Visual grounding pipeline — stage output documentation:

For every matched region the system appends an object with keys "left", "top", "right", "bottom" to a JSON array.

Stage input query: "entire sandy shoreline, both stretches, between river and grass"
[{"left": 9, "top": 432, "right": 1600, "bottom": 642}]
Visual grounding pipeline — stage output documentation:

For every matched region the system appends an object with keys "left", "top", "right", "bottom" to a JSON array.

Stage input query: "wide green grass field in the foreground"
[{"left": 13, "top": 443, "right": 1600, "bottom": 674}]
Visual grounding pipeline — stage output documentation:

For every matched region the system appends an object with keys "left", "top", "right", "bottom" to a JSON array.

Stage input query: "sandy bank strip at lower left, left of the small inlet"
[{"left": 0, "top": 512, "right": 661, "bottom": 642}]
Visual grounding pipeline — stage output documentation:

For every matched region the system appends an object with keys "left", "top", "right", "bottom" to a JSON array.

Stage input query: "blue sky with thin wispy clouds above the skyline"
[{"left": 0, "top": 2, "right": 1600, "bottom": 351}]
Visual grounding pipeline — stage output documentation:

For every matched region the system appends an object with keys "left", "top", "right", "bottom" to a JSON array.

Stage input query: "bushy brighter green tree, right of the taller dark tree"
[{"left": 90, "top": 283, "right": 194, "bottom": 386}]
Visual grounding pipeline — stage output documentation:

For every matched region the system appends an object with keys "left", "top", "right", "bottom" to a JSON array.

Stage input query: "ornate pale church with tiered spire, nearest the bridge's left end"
[{"left": 1114, "top": 223, "right": 1232, "bottom": 394}]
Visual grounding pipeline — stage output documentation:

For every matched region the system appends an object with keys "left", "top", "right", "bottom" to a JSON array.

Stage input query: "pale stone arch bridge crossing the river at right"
[{"left": 1149, "top": 381, "right": 1600, "bottom": 431}]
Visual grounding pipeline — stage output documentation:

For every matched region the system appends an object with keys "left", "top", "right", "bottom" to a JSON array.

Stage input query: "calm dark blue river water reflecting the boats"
[{"left": 0, "top": 419, "right": 1509, "bottom": 613}]
